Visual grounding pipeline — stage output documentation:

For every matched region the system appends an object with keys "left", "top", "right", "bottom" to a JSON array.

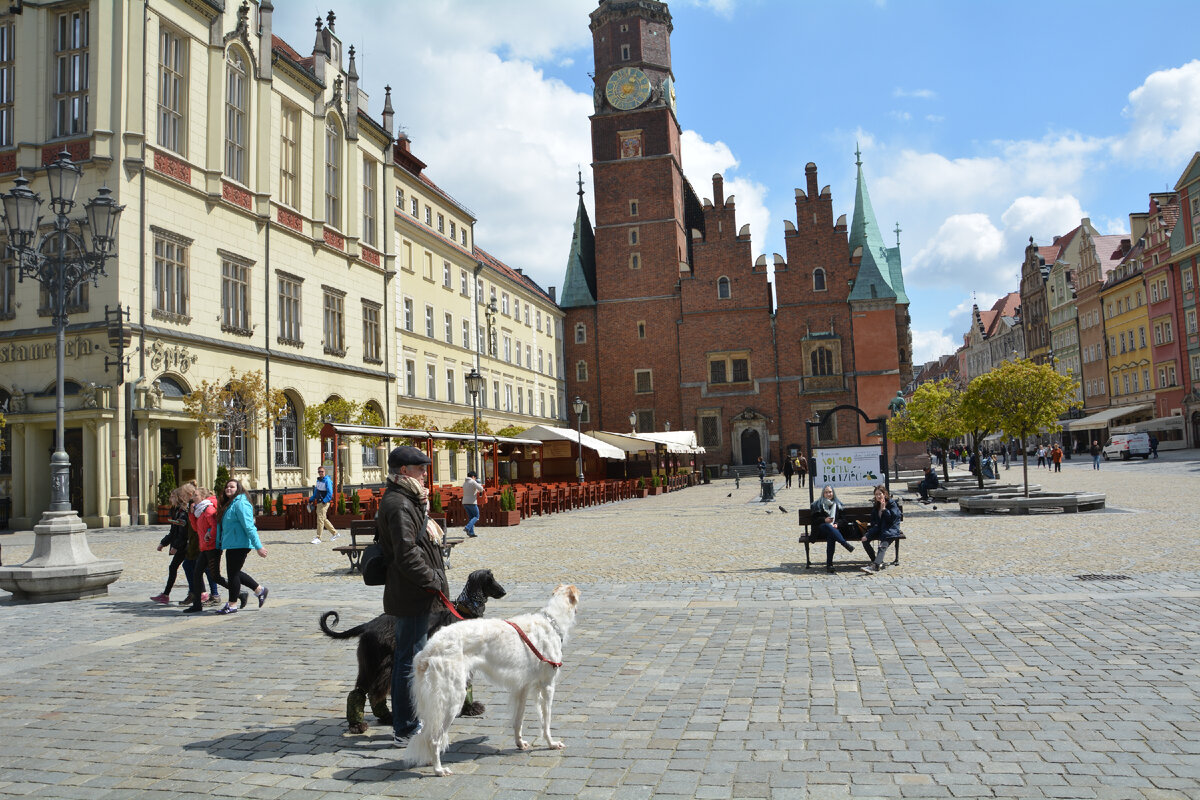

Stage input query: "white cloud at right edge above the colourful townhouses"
[{"left": 1112, "top": 60, "right": 1200, "bottom": 164}]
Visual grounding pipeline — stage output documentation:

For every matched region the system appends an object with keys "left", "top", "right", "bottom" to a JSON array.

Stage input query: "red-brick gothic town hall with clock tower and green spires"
[{"left": 560, "top": 0, "right": 912, "bottom": 464}]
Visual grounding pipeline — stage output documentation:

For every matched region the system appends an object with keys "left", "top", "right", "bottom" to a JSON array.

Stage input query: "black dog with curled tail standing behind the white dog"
[{"left": 320, "top": 570, "right": 508, "bottom": 733}]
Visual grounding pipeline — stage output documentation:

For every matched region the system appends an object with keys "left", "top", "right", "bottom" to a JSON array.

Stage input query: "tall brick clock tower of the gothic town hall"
[{"left": 563, "top": 0, "right": 691, "bottom": 431}]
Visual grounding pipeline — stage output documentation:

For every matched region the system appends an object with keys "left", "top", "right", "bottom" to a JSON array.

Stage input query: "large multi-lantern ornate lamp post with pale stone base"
[{"left": 0, "top": 150, "right": 124, "bottom": 600}]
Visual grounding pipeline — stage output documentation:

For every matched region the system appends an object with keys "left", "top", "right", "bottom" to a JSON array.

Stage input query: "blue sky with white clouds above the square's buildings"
[{"left": 274, "top": 0, "right": 1200, "bottom": 362}]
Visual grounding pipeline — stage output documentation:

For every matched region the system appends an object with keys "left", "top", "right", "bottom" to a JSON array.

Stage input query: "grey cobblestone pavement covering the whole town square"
[{"left": 0, "top": 453, "right": 1200, "bottom": 800}]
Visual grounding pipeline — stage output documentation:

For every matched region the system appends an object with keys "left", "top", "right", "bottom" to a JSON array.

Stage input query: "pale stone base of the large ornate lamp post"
[{"left": 0, "top": 510, "right": 125, "bottom": 602}]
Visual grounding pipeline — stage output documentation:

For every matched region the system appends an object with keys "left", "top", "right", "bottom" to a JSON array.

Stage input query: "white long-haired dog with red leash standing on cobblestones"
[{"left": 404, "top": 585, "right": 580, "bottom": 775}]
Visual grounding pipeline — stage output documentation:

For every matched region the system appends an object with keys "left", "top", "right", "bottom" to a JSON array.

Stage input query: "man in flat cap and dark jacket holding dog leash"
[{"left": 376, "top": 446, "right": 450, "bottom": 746}]
